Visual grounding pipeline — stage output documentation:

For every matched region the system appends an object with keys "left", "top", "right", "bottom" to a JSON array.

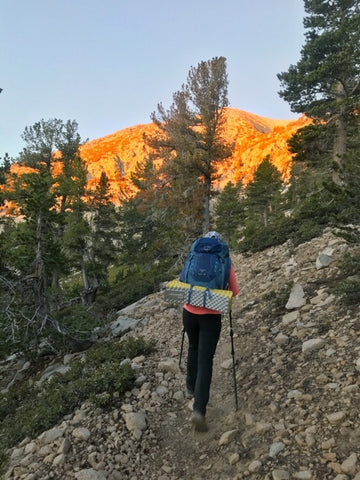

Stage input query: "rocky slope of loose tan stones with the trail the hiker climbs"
[{"left": 5, "top": 229, "right": 360, "bottom": 480}]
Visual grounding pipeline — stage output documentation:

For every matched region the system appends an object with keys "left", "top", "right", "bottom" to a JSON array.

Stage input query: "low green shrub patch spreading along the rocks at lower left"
[{"left": 0, "top": 337, "right": 154, "bottom": 466}]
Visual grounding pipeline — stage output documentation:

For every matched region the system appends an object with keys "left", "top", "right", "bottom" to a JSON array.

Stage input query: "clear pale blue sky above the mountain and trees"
[{"left": 0, "top": 0, "right": 305, "bottom": 159}]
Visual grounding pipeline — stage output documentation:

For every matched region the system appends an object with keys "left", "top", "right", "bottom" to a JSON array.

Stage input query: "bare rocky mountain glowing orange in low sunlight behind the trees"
[{"left": 81, "top": 108, "right": 309, "bottom": 199}]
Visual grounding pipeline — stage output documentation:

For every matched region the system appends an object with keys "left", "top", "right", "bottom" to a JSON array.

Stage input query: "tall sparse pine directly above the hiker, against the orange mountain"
[{"left": 149, "top": 57, "right": 232, "bottom": 234}]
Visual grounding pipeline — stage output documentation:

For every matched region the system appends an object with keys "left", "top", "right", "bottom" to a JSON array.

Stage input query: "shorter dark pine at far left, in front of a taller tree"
[{"left": 3, "top": 164, "right": 66, "bottom": 348}]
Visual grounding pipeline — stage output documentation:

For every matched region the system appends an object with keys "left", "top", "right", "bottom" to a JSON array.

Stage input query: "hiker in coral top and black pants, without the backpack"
[{"left": 183, "top": 231, "right": 239, "bottom": 432}]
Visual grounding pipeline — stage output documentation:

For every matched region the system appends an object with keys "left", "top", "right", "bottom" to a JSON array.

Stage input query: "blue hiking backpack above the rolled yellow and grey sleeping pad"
[{"left": 180, "top": 237, "right": 231, "bottom": 290}]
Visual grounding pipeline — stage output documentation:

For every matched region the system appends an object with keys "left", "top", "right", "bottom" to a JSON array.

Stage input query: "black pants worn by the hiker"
[{"left": 183, "top": 308, "right": 221, "bottom": 415}]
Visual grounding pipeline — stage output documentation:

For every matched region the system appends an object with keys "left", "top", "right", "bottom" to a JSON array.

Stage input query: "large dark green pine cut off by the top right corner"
[{"left": 278, "top": 0, "right": 360, "bottom": 185}]
